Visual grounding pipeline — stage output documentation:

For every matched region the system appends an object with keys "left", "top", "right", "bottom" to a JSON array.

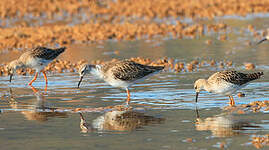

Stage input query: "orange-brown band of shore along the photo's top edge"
[{"left": 0, "top": 0, "right": 269, "bottom": 19}]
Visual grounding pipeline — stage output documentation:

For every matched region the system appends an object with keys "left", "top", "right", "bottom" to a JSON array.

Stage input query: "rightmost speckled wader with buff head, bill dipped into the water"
[{"left": 194, "top": 71, "right": 263, "bottom": 105}]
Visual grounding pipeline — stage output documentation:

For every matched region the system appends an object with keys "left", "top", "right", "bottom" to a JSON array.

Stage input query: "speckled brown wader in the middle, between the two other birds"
[{"left": 78, "top": 60, "right": 164, "bottom": 104}]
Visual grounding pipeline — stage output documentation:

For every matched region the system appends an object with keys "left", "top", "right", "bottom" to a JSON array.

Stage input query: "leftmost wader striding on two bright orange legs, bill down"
[{"left": 7, "top": 47, "right": 66, "bottom": 85}]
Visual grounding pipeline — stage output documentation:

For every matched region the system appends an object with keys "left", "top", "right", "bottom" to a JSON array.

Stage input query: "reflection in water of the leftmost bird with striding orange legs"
[{"left": 9, "top": 86, "right": 67, "bottom": 122}]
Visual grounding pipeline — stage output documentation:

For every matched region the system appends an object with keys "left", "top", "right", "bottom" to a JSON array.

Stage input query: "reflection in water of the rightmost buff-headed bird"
[{"left": 195, "top": 108, "right": 261, "bottom": 137}]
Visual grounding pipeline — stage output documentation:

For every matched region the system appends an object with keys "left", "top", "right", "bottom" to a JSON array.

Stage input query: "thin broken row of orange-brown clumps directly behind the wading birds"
[{"left": 0, "top": 57, "right": 255, "bottom": 76}]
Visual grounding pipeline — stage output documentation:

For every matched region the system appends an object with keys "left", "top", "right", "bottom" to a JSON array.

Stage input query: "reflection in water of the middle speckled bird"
[{"left": 80, "top": 109, "right": 165, "bottom": 133}]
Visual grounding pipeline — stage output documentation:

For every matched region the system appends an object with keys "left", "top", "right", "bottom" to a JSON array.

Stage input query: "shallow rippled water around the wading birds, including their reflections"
[{"left": 0, "top": 18, "right": 269, "bottom": 150}]
